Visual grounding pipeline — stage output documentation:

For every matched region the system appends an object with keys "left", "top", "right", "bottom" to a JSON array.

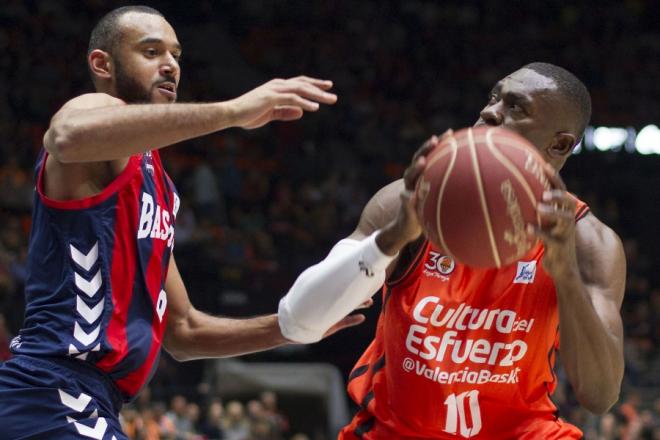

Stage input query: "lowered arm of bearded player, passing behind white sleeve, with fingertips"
[{"left": 163, "top": 256, "right": 371, "bottom": 361}]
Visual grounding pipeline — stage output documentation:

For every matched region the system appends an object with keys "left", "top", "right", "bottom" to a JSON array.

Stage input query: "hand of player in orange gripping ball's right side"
[{"left": 527, "top": 166, "right": 577, "bottom": 278}]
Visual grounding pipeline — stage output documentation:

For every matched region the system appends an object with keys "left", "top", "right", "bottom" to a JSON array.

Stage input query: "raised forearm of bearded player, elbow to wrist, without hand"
[{"left": 44, "top": 102, "right": 232, "bottom": 163}]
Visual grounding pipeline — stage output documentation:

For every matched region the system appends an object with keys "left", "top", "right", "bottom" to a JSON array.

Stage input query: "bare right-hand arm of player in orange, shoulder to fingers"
[{"left": 536, "top": 171, "right": 626, "bottom": 414}]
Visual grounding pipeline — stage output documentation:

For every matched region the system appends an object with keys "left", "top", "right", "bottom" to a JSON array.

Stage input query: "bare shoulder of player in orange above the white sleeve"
[{"left": 350, "top": 179, "right": 404, "bottom": 239}]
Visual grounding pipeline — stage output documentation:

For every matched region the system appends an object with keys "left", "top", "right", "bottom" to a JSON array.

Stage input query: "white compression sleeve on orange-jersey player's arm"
[{"left": 278, "top": 231, "right": 398, "bottom": 344}]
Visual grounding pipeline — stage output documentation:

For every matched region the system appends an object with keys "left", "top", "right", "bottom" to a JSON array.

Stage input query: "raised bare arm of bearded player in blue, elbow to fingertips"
[{"left": 44, "top": 76, "right": 337, "bottom": 163}]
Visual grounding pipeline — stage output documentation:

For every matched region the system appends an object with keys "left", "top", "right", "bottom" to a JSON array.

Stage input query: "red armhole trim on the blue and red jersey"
[{"left": 36, "top": 152, "right": 142, "bottom": 210}]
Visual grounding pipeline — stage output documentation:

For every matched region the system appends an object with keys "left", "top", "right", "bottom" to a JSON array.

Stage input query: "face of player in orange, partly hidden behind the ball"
[{"left": 475, "top": 69, "right": 564, "bottom": 161}]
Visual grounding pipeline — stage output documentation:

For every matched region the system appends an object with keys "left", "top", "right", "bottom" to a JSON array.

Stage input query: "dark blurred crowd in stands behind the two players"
[{"left": 0, "top": 0, "right": 660, "bottom": 440}]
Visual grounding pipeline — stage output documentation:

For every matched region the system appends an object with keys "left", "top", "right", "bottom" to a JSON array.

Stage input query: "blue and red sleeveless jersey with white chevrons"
[{"left": 11, "top": 151, "right": 180, "bottom": 400}]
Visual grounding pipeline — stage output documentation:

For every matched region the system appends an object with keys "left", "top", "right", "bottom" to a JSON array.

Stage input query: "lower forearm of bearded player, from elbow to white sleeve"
[{"left": 165, "top": 310, "right": 289, "bottom": 361}]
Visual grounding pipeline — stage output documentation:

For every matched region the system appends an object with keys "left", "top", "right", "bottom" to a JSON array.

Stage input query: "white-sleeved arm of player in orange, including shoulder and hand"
[{"left": 278, "top": 136, "right": 438, "bottom": 343}]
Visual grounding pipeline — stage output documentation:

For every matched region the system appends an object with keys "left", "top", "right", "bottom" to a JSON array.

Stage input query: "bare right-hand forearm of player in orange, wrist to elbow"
[{"left": 555, "top": 269, "right": 624, "bottom": 414}]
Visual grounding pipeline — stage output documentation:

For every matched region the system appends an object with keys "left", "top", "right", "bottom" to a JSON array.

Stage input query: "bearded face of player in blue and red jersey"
[{"left": 113, "top": 13, "right": 181, "bottom": 103}]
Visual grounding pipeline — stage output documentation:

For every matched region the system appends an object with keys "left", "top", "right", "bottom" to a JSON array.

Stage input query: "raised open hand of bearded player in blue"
[{"left": 228, "top": 76, "right": 337, "bottom": 129}]
